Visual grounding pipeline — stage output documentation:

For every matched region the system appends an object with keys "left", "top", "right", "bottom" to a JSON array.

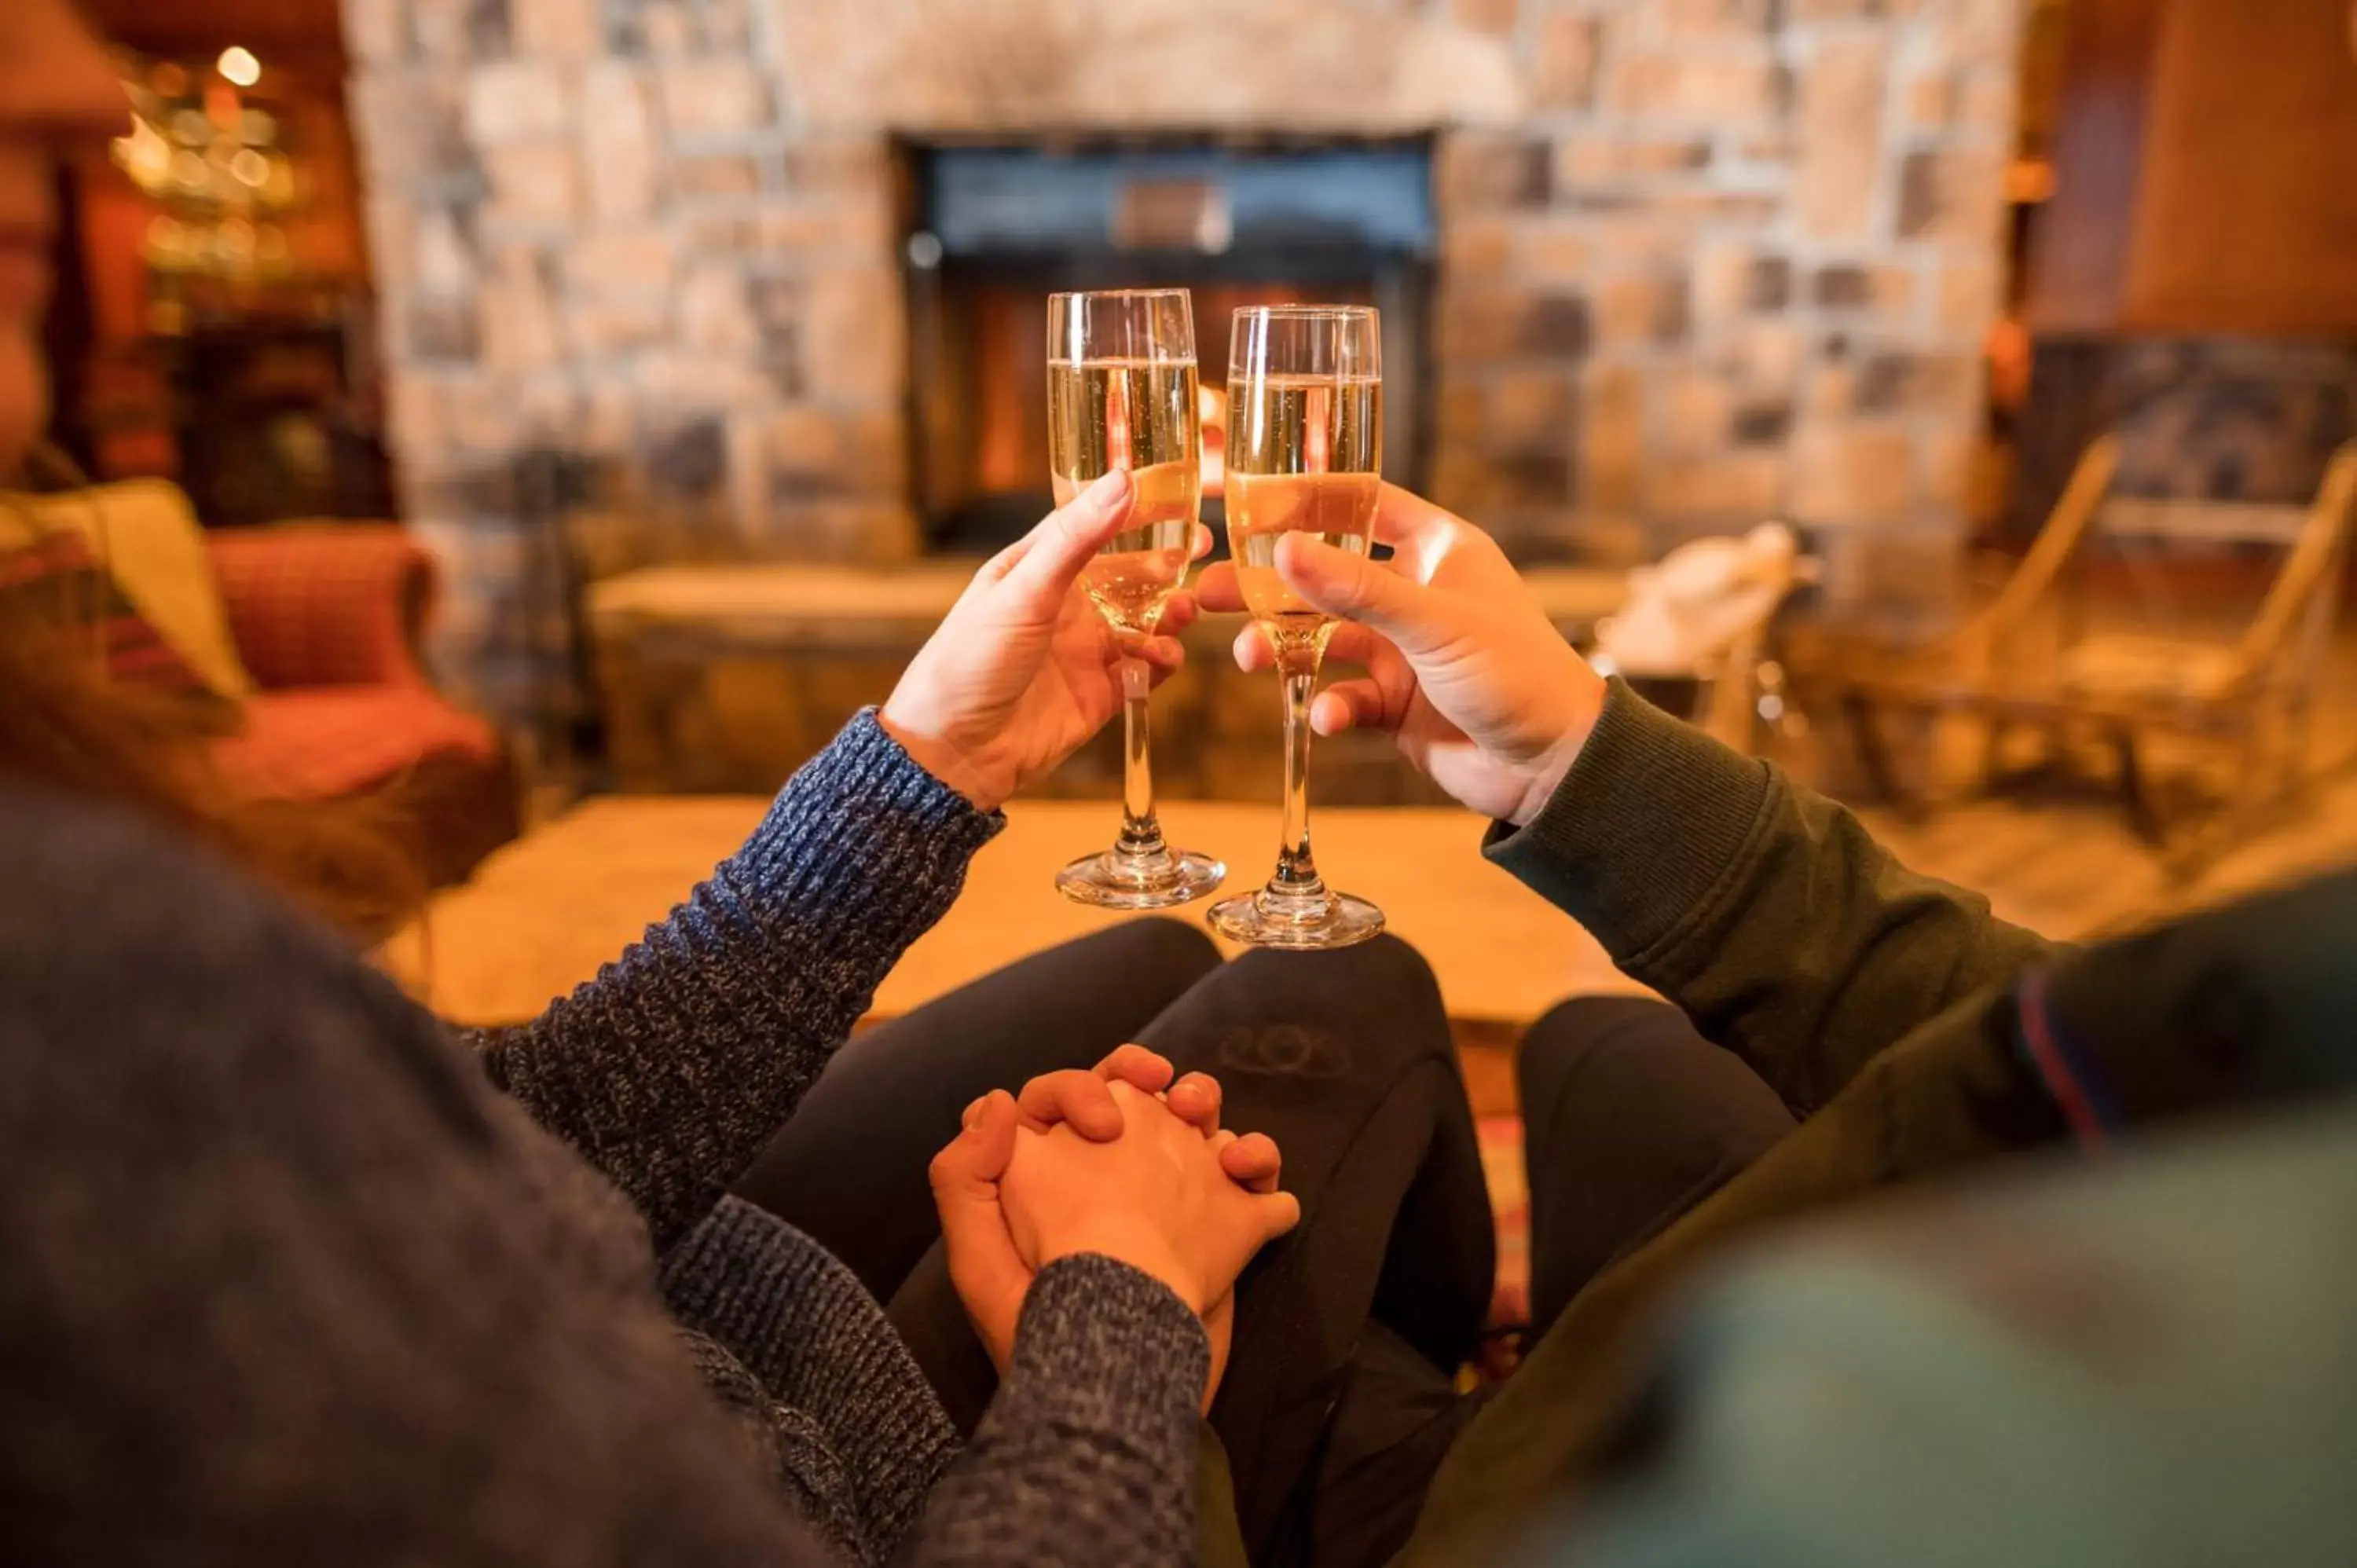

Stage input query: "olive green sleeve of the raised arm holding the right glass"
[{"left": 1485, "top": 681, "right": 2051, "bottom": 1116}]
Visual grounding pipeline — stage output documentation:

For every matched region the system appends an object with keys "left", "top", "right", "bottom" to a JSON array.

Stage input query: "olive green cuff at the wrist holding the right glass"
[{"left": 1483, "top": 679, "right": 1775, "bottom": 962}]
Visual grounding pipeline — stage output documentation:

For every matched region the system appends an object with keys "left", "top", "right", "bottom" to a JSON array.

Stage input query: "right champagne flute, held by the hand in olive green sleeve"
[{"left": 1211, "top": 304, "right": 1384, "bottom": 948}]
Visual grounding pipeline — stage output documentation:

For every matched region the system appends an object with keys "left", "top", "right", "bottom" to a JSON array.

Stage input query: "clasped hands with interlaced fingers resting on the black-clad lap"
[{"left": 931, "top": 1045, "right": 1301, "bottom": 1410}]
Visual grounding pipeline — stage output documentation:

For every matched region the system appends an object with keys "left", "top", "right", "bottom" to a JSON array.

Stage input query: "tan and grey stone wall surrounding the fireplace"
[{"left": 344, "top": 0, "right": 2018, "bottom": 709}]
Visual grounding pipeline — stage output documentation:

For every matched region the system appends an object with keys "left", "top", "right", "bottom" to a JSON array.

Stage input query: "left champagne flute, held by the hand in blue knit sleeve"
[{"left": 1047, "top": 288, "right": 1228, "bottom": 910}]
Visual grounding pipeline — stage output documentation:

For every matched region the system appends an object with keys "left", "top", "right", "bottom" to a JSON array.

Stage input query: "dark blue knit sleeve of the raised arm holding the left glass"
[{"left": 483, "top": 709, "right": 1004, "bottom": 1252}]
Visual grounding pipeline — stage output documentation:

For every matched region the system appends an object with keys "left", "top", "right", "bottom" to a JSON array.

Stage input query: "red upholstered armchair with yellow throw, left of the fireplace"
[{"left": 205, "top": 523, "right": 519, "bottom": 885}]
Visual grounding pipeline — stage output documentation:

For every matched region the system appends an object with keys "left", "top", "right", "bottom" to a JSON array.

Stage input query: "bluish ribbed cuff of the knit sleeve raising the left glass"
[{"left": 719, "top": 707, "right": 1006, "bottom": 922}]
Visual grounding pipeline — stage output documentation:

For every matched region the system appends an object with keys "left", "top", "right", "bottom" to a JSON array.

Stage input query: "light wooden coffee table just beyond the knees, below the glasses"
[{"left": 384, "top": 797, "right": 1638, "bottom": 1040}]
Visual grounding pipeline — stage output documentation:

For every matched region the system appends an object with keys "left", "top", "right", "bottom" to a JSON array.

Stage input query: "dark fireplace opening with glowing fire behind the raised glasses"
[{"left": 898, "top": 137, "right": 1438, "bottom": 554}]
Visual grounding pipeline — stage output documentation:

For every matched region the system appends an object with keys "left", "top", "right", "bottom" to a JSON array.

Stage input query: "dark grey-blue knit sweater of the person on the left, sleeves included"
[{"left": 0, "top": 716, "right": 1207, "bottom": 1566}]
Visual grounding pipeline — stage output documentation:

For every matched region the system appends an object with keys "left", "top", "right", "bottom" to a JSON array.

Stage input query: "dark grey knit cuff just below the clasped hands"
[{"left": 1009, "top": 1252, "right": 1211, "bottom": 1442}]
